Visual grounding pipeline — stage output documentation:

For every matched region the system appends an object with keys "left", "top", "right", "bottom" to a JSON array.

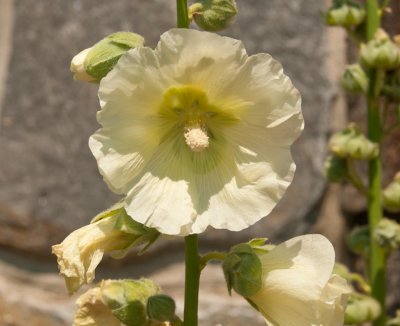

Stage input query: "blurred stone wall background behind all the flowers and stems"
[{"left": 0, "top": 0, "right": 400, "bottom": 326}]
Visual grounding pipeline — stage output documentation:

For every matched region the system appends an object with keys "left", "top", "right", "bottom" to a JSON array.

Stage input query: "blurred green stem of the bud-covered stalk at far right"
[{"left": 366, "top": 0, "right": 386, "bottom": 326}]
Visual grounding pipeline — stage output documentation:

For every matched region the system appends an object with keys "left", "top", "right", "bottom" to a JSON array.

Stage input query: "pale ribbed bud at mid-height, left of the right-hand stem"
[{"left": 329, "top": 124, "right": 379, "bottom": 160}]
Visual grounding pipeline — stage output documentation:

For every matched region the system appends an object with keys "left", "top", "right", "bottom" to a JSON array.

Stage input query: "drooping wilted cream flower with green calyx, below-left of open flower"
[{"left": 52, "top": 204, "right": 159, "bottom": 293}]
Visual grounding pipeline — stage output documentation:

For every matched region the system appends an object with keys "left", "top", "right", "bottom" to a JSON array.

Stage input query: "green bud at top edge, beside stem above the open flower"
[{"left": 189, "top": 0, "right": 238, "bottom": 32}]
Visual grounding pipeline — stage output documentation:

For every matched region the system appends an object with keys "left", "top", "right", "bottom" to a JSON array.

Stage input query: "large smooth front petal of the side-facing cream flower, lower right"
[{"left": 249, "top": 234, "right": 335, "bottom": 326}]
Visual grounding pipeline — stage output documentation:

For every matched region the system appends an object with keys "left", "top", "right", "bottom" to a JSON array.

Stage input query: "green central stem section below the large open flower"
[{"left": 183, "top": 234, "right": 200, "bottom": 326}]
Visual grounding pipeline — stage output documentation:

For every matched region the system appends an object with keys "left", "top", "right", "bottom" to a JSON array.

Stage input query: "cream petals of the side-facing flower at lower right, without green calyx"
[{"left": 247, "top": 234, "right": 351, "bottom": 326}]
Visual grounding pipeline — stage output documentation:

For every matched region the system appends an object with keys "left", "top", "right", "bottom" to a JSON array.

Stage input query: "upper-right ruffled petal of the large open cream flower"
[{"left": 220, "top": 53, "right": 304, "bottom": 144}]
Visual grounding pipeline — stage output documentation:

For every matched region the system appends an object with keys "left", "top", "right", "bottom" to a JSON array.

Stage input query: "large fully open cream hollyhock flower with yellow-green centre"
[{"left": 89, "top": 29, "right": 303, "bottom": 236}]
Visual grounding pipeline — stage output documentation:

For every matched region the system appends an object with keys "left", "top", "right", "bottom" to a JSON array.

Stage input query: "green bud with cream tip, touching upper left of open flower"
[{"left": 71, "top": 32, "right": 144, "bottom": 82}]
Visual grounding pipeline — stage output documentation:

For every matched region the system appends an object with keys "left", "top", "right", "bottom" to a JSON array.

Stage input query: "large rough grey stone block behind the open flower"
[{"left": 0, "top": 0, "right": 331, "bottom": 254}]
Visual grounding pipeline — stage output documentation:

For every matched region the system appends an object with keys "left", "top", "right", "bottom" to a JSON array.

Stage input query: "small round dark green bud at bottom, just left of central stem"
[{"left": 147, "top": 294, "right": 176, "bottom": 322}]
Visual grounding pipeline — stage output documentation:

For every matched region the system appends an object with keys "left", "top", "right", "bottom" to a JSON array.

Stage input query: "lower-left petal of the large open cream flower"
[{"left": 125, "top": 134, "right": 196, "bottom": 235}]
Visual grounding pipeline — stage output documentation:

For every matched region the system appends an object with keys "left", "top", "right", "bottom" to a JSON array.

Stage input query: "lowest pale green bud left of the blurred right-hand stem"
[{"left": 344, "top": 292, "right": 381, "bottom": 325}]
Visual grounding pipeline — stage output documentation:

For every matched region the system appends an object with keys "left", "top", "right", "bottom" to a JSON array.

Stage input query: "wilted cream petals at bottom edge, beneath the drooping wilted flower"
[{"left": 72, "top": 287, "right": 121, "bottom": 326}]
